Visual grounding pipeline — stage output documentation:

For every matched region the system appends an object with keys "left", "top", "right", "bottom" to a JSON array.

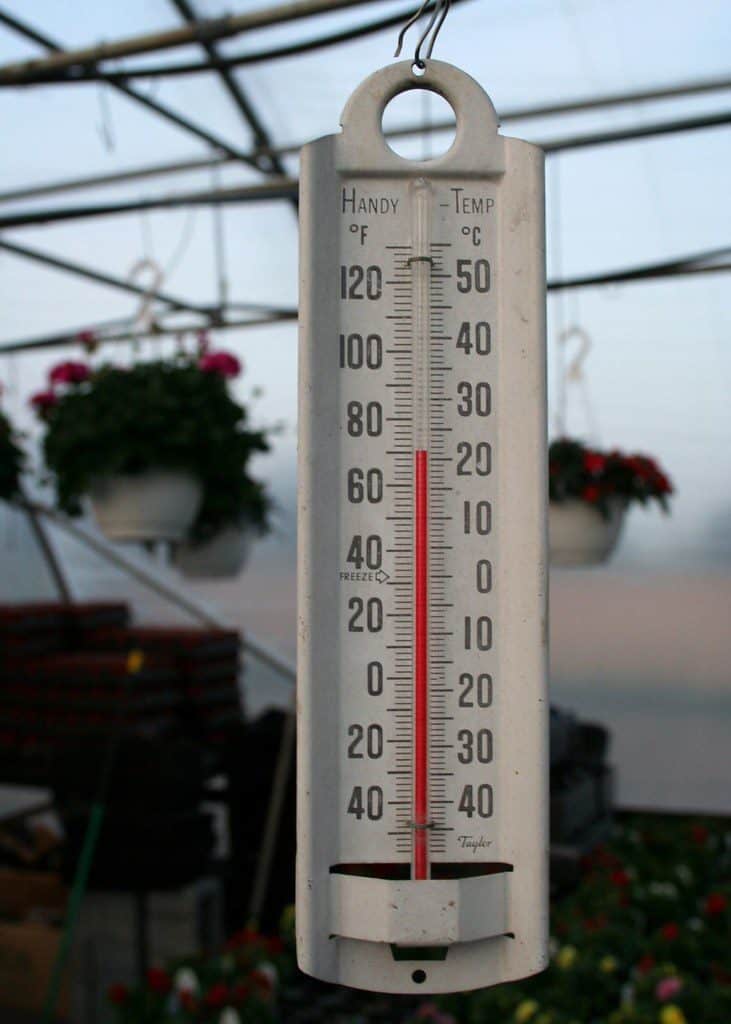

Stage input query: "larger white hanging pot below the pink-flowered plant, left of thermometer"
[{"left": 89, "top": 470, "right": 203, "bottom": 541}]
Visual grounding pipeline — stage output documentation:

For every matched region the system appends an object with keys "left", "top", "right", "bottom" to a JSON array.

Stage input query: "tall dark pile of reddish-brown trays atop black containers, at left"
[{"left": 0, "top": 603, "right": 243, "bottom": 892}]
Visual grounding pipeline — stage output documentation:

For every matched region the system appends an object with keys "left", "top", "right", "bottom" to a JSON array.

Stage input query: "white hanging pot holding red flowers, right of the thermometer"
[{"left": 549, "top": 498, "right": 627, "bottom": 566}]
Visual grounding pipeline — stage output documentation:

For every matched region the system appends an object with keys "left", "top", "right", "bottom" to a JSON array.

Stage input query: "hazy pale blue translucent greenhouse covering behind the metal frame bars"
[{"left": 0, "top": 0, "right": 731, "bottom": 810}]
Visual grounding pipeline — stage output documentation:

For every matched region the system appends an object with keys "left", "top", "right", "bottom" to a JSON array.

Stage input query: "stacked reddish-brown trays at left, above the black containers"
[{"left": 0, "top": 603, "right": 241, "bottom": 755}]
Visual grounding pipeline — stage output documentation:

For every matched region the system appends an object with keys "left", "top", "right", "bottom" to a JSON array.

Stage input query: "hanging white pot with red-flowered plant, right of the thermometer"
[{"left": 549, "top": 438, "right": 673, "bottom": 566}]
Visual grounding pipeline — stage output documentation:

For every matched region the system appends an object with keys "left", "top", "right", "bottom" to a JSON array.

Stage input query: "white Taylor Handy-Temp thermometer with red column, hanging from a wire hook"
[{"left": 297, "top": 61, "right": 548, "bottom": 992}]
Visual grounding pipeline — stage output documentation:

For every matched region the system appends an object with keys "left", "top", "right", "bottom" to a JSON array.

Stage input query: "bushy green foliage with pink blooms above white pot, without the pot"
[{"left": 34, "top": 353, "right": 270, "bottom": 541}]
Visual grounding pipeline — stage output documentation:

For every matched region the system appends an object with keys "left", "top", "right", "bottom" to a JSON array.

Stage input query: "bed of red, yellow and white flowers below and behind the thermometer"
[{"left": 110, "top": 815, "right": 731, "bottom": 1024}]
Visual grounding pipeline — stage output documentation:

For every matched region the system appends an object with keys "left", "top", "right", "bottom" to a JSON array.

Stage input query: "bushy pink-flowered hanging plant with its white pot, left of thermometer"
[{"left": 32, "top": 352, "right": 268, "bottom": 542}]
